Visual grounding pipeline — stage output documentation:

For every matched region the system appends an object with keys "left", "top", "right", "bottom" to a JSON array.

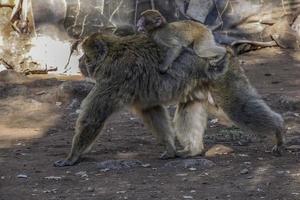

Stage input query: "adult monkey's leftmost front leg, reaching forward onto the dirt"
[{"left": 54, "top": 86, "right": 118, "bottom": 167}]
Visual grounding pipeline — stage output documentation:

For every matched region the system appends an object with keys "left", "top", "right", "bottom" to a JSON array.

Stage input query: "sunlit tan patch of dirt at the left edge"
[{"left": 0, "top": 96, "right": 58, "bottom": 148}]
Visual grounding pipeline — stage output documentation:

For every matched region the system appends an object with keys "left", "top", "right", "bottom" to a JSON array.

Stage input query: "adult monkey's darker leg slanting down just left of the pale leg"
[{"left": 138, "top": 106, "right": 176, "bottom": 159}]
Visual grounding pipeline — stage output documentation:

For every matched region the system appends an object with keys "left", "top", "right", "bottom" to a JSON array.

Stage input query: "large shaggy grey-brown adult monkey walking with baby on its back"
[{"left": 54, "top": 33, "right": 283, "bottom": 167}]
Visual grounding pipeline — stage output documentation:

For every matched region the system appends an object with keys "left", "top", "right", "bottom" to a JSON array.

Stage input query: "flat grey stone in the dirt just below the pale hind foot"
[{"left": 165, "top": 158, "right": 216, "bottom": 169}]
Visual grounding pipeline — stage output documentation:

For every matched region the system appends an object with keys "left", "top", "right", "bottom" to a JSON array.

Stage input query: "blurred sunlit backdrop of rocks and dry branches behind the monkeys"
[{"left": 0, "top": 0, "right": 300, "bottom": 74}]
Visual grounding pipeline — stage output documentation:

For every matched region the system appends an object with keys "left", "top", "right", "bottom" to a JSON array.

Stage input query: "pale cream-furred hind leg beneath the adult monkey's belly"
[{"left": 174, "top": 101, "right": 207, "bottom": 157}]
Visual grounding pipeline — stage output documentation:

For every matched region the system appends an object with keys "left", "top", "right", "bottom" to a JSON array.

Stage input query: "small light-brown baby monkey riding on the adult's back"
[{"left": 137, "top": 10, "right": 226, "bottom": 73}]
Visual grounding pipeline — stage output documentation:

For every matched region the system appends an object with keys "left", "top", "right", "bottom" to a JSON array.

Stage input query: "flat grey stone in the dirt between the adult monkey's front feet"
[{"left": 97, "top": 160, "right": 143, "bottom": 170}]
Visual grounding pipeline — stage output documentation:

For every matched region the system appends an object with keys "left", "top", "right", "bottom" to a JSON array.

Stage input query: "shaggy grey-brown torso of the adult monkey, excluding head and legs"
[{"left": 90, "top": 34, "right": 207, "bottom": 106}]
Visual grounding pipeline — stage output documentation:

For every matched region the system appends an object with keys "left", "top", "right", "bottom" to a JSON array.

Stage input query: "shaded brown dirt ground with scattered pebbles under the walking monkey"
[{"left": 0, "top": 48, "right": 300, "bottom": 200}]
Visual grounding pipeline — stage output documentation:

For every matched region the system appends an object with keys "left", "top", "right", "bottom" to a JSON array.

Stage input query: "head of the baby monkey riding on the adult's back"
[{"left": 136, "top": 10, "right": 167, "bottom": 33}]
